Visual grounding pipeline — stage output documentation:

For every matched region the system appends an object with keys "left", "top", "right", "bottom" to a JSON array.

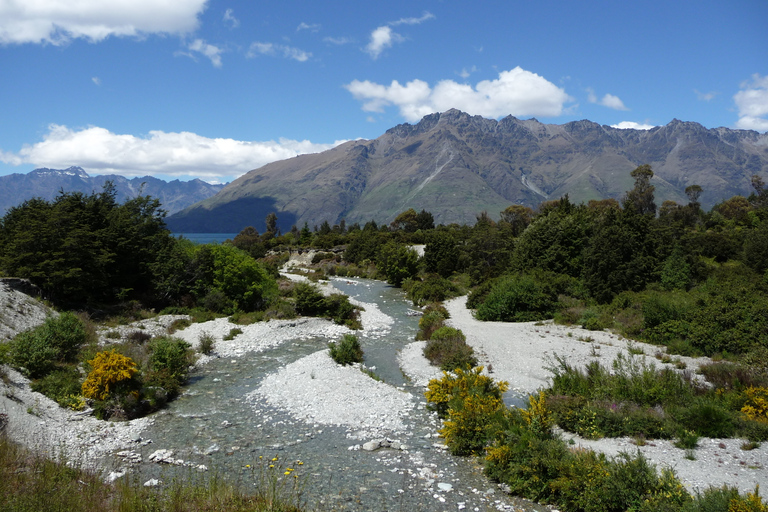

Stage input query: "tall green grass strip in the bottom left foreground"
[{"left": 0, "top": 434, "right": 303, "bottom": 512}]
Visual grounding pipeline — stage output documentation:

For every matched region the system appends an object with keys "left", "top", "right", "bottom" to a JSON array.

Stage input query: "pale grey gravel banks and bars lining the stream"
[{"left": 0, "top": 280, "right": 768, "bottom": 505}]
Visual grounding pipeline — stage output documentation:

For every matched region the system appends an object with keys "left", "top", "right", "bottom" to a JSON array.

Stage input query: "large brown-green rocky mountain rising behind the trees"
[{"left": 168, "top": 110, "right": 768, "bottom": 232}]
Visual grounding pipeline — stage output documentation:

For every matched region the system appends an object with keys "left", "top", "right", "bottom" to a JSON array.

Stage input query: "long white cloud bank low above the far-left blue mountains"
[{"left": 0, "top": 124, "right": 344, "bottom": 181}]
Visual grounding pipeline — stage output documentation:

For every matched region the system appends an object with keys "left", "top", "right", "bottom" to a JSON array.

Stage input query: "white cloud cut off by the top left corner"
[{"left": 0, "top": 0, "right": 206, "bottom": 45}]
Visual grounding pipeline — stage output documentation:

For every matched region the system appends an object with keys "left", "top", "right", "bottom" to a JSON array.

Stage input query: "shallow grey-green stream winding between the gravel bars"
[{"left": 134, "top": 279, "right": 548, "bottom": 511}]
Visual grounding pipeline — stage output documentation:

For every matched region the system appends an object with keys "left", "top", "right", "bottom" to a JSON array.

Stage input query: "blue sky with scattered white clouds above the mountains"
[{"left": 0, "top": 0, "right": 768, "bottom": 182}]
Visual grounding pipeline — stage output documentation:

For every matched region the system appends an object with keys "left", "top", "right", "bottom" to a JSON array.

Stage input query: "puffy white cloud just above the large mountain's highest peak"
[{"left": 344, "top": 67, "right": 573, "bottom": 122}]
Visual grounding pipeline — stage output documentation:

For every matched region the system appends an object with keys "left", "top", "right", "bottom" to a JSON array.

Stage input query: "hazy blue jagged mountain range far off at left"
[{"left": 0, "top": 167, "right": 224, "bottom": 214}]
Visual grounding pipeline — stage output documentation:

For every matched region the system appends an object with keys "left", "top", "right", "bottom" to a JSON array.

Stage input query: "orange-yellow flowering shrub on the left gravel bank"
[{"left": 82, "top": 350, "right": 139, "bottom": 400}]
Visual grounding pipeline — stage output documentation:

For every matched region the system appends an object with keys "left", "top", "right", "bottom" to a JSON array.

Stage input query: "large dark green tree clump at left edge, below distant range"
[{"left": 0, "top": 182, "right": 174, "bottom": 303}]
